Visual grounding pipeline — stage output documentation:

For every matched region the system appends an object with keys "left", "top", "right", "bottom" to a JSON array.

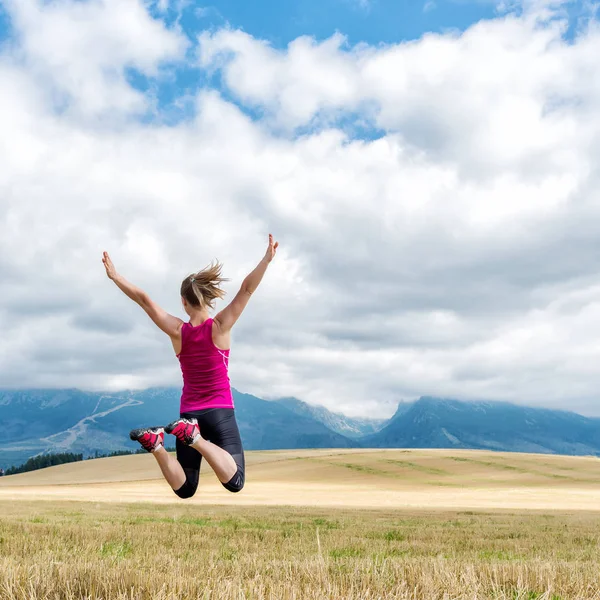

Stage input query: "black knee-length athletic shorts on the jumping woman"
[{"left": 175, "top": 408, "right": 245, "bottom": 498}]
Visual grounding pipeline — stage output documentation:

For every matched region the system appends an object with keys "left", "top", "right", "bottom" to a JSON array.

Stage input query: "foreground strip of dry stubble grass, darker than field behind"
[{"left": 0, "top": 501, "right": 600, "bottom": 600}]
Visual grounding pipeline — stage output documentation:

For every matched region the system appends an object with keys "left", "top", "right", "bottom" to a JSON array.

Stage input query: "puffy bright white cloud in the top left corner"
[{"left": 4, "top": 0, "right": 187, "bottom": 119}]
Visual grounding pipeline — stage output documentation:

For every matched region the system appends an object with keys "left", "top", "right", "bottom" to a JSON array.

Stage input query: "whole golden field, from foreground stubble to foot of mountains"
[{"left": 0, "top": 450, "right": 600, "bottom": 600}]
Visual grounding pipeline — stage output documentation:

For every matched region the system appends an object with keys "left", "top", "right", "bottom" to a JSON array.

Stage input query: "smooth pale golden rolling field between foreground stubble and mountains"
[{"left": 0, "top": 450, "right": 600, "bottom": 510}]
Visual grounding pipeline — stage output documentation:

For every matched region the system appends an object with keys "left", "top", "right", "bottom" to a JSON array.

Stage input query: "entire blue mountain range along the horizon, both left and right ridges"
[{"left": 0, "top": 388, "right": 600, "bottom": 468}]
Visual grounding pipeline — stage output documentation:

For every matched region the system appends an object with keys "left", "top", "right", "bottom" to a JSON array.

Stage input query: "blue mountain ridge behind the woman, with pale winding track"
[{"left": 0, "top": 388, "right": 358, "bottom": 468}]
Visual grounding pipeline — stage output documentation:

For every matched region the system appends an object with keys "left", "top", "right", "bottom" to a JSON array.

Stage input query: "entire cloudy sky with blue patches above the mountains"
[{"left": 0, "top": 0, "right": 600, "bottom": 417}]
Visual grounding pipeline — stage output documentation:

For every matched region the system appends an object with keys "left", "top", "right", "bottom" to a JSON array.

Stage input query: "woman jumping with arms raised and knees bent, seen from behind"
[{"left": 102, "top": 235, "right": 279, "bottom": 498}]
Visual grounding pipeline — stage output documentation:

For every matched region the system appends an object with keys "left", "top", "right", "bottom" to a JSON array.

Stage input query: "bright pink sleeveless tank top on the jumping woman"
[{"left": 177, "top": 319, "right": 233, "bottom": 413}]
